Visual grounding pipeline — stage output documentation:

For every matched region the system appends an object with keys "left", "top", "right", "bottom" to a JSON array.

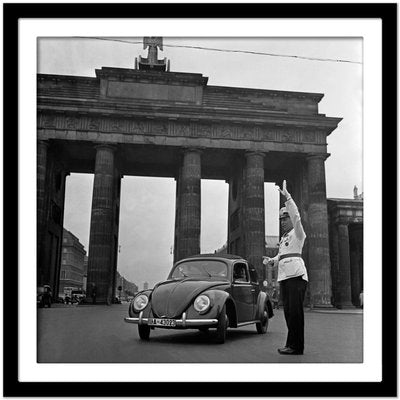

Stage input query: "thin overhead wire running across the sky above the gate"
[{"left": 75, "top": 36, "right": 362, "bottom": 64}]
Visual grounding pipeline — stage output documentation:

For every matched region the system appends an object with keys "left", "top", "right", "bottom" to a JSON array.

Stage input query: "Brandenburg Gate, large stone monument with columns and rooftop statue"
[{"left": 37, "top": 37, "right": 340, "bottom": 307}]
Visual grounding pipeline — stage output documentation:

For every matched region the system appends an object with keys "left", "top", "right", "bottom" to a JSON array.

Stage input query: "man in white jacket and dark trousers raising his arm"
[{"left": 263, "top": 181, "right": 308, "bottom": 355}]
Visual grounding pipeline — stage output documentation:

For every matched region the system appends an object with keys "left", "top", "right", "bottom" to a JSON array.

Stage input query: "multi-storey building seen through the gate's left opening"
[{"left": 58, "top": 229, "right": 87, "bottom": 298}]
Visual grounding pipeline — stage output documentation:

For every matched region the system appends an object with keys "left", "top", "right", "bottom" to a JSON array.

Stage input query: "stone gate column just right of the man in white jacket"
[{"left": 306, "top": 154, "right": 331, "bottom": 307}]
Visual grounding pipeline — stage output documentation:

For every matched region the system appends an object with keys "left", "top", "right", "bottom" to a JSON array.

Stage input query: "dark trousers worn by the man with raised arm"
[{"left": 280, "top": 276, "right": 307, "bottom": 351}]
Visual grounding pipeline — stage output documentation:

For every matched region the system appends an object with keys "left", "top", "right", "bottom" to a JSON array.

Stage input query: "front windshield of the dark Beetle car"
[{"left": 171, "top": 260, "right": 228, "bottom": 278}]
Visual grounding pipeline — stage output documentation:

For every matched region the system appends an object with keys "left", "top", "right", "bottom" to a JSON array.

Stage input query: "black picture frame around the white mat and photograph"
[{"left": 3, "top": 3, "right": 397, "bottom": 397}]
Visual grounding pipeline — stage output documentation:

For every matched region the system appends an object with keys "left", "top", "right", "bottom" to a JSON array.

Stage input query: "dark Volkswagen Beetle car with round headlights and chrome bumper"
[{"left": 125, "top": 254, "right": 273, "bottom": 343}]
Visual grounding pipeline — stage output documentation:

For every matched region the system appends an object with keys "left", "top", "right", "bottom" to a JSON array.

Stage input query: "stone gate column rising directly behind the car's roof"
[{"left": 174, "top": 149, "right": 201, "bottom": 261}]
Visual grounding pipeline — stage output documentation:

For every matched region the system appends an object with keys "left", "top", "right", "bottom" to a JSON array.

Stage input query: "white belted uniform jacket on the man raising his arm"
[{"left": 271, "top": 199, "right": 308, "bottom": 282}]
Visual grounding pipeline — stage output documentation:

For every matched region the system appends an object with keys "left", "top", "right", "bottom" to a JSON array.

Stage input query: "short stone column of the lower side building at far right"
[{"left": 338, "top": 222, "right": 353, "bottom": 308}]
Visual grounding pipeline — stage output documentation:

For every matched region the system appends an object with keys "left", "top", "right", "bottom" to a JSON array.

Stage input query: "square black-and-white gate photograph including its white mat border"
[{"left": 4, "top": 3, "right": 396, "bottom": 395}]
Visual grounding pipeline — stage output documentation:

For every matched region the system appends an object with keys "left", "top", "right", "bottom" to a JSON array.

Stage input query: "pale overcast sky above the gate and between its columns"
[{"left": 38, "top": 37, "right": 363, "bottom": 288}]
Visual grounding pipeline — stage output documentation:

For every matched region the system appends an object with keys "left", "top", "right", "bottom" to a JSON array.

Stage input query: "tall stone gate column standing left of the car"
[{"left": 87, "top": 145, "right": 115, "bottom": 304}]
